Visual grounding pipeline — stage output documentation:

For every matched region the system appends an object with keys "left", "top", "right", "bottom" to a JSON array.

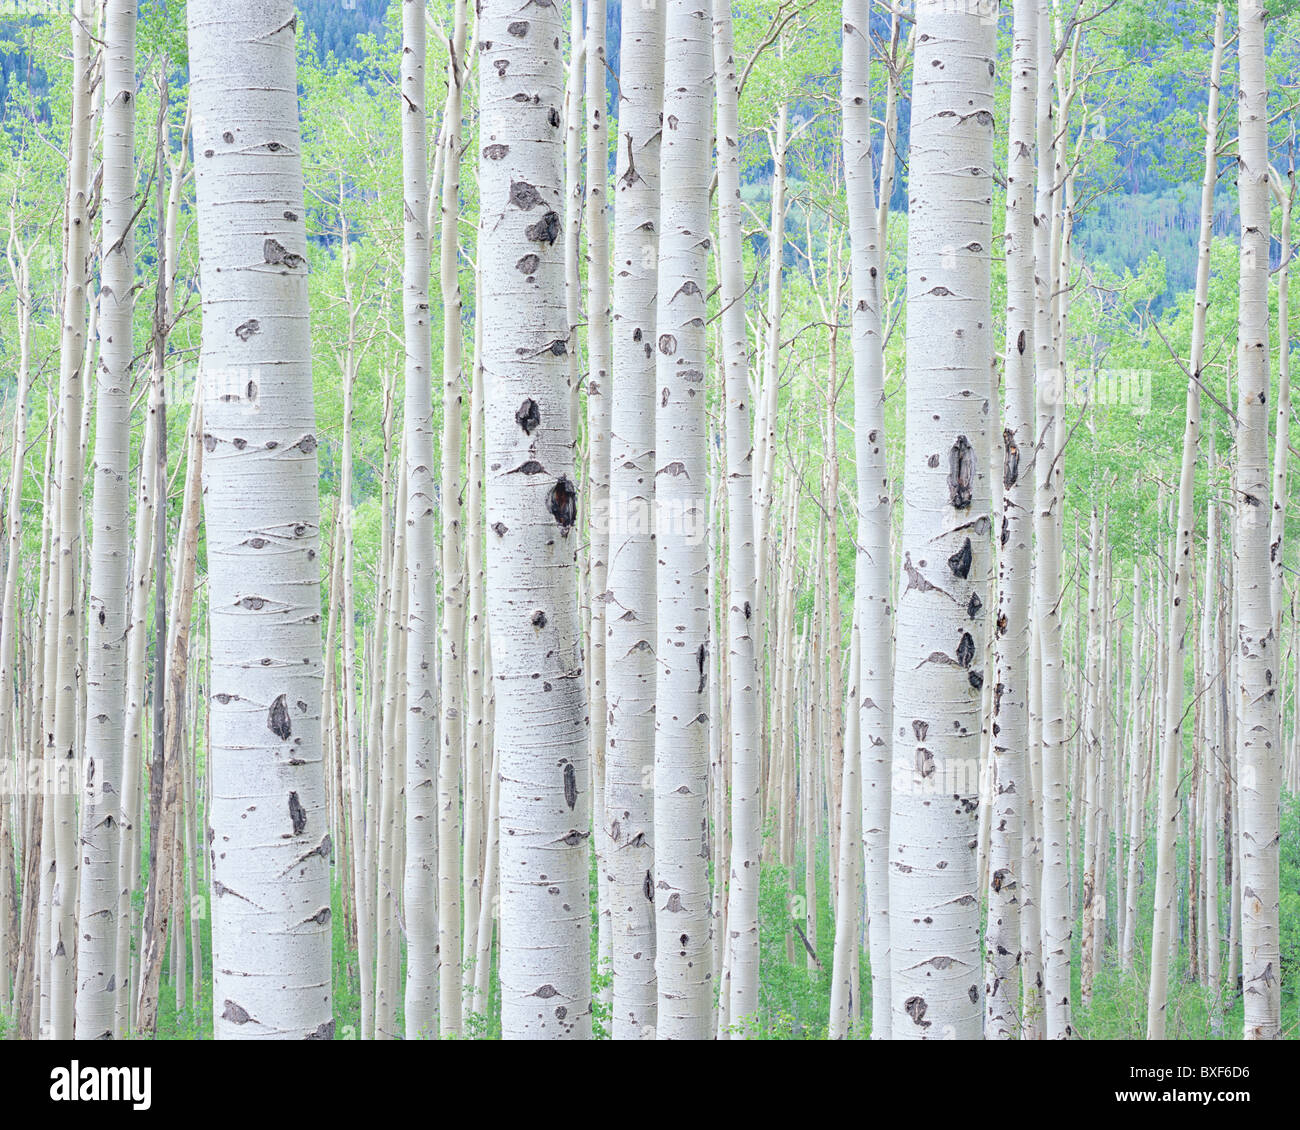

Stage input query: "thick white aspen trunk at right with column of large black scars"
[{"left": 889, "top": 0, "right": 997, "bottom": 1039}]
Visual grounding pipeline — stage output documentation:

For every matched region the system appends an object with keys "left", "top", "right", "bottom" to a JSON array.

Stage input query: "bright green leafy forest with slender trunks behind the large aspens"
[{"left": 0, "top": 0, "right": 1300, "bottom": 1039}]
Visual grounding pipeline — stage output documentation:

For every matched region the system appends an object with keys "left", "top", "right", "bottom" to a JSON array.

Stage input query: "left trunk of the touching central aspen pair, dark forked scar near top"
[{"left": 599, "top": 4, "right": 664, "bottom": 1039}]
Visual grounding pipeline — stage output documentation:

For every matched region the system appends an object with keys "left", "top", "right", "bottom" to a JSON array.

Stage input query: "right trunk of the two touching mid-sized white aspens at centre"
[{"left": 654, "top": 0, "right": 712, "bottom": 1039}]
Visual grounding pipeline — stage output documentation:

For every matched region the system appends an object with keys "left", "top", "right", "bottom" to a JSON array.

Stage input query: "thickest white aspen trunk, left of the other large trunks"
[{"left": 187, "top": 0, "right": 334, "bottom": 1039}]
